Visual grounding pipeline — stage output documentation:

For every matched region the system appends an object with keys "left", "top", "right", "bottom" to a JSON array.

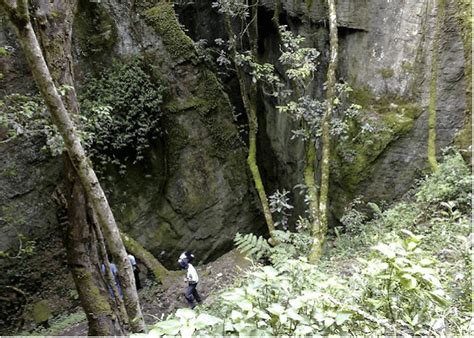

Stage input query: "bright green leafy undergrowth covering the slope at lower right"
[{"left": 139, "top": 153, "right": 472, "bottom": 336}]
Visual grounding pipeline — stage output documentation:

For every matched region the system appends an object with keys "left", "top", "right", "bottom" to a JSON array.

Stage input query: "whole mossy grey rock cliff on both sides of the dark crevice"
[{"left": 0, "top": 0, "right": 471, "bottom": 266}]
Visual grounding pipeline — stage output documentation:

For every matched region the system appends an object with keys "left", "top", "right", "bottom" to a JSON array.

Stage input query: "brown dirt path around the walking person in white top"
[{"left": 59, "top": 250, "right": 249, "bottom": 336}]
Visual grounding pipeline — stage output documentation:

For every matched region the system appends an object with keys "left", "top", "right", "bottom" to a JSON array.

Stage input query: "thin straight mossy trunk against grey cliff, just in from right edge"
[{"left": 428, "top": 0, "right": 445, "bottom": 171}]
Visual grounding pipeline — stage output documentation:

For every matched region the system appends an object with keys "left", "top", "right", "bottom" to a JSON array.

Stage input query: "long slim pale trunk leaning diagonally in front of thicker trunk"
[{"left": 0, "top": 0, "right": 146, "bottom": 332}]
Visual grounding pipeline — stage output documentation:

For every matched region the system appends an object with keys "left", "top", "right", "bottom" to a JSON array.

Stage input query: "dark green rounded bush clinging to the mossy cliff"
[{"left": 81, "top": 58, "right": 165, "bottom": 173}]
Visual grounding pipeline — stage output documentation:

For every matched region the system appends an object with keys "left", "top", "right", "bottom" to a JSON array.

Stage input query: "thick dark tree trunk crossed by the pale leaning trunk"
[{"left": 34, "top": 0, "right": 128, "bottom": 335}]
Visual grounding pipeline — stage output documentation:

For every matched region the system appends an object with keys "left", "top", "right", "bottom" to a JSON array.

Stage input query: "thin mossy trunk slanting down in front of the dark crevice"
[{"left": 224, "top": 2, "right": 275, "bottom": 242}]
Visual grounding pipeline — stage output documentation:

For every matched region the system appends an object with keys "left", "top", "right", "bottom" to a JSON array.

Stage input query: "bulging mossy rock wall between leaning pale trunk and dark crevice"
[{"left": 89, "top": 3, "right": 263, "bottom": 268}]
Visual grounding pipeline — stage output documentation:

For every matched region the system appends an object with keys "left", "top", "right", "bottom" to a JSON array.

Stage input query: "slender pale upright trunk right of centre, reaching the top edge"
[{"left": 309, "top": 0, "right": 338, "bottom": 262}]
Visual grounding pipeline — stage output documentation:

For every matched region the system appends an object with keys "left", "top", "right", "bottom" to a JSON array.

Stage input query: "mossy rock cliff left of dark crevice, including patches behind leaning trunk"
[{"left": 0, "top": 1, "right": 261, "bottom": 268}]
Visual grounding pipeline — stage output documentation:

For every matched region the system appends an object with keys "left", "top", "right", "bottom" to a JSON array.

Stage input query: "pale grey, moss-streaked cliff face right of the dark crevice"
[{"left": 181, "top": 0, "right": 472, "bottom": 221}]
